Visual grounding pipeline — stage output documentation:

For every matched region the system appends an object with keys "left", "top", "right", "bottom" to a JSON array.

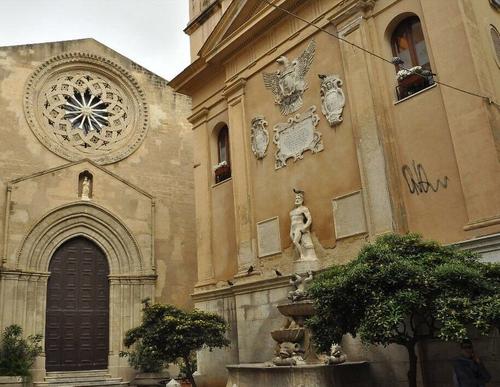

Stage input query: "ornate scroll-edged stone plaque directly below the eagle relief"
[{"left": 273, "top": 106, "right": 323, "bottom": 169}]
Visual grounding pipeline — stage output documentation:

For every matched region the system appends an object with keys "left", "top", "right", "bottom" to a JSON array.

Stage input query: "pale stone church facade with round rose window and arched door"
[{"left": 0, "top": 39, "right": 196, "bottom": 383}]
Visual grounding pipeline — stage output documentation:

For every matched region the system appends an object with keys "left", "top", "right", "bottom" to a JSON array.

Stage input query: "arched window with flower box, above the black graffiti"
[{"left": 391, "top": 16, "right": 434, "bottom": 99}]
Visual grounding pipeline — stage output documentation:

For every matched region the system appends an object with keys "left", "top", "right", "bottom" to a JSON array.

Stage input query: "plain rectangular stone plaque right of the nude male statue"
[{"left": 332, "top": 191, "right": 367, "bottom": 239}]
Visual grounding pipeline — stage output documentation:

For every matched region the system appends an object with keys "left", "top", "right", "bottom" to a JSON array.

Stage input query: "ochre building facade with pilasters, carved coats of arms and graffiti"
[{"left": 171, "top": 0, "right": 500, "bottom": 386}]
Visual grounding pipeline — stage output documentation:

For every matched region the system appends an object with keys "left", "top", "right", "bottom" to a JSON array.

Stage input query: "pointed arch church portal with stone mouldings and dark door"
[{"left": 0, "top": 201, "right": 156, "bottom": 377}]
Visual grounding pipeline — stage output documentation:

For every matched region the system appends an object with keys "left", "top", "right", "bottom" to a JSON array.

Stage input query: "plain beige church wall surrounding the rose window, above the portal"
[{"left": 0, "top": 39, "right": 196, "bottom": 307}]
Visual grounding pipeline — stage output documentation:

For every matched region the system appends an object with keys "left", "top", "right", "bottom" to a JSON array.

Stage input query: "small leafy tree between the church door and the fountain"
[{"left": 122, "top": 300, "right": 229, "bottom": 387}]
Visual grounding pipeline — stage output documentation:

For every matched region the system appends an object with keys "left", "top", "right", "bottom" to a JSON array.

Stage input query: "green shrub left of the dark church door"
[{"left": 0, "top": 324, "right": 42, "bottom": 387}]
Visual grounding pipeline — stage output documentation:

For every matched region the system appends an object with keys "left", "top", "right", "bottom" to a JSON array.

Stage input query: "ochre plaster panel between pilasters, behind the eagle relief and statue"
[{"left": 245, "top": 29, "right": 361, "bottom": 249}]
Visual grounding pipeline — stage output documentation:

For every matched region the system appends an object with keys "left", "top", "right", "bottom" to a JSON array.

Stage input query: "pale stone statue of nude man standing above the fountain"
[{"left": 290, "top": 189, "right": 317, "bottom": 260}]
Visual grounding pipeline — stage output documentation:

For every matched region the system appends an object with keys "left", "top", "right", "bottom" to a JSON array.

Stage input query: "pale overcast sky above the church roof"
[{"left": 0, "top": 0, "right": 189, "bottom": 80}]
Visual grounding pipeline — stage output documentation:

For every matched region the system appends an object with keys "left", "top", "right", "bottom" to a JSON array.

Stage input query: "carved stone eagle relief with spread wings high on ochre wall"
[{"left": 262, "top": 39, "right": 316, "bottom": 115}]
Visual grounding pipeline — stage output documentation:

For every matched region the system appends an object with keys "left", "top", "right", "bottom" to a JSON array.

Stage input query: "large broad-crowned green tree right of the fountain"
[{"left": 308, "top": 234, "right": 500, "bottom": 387}]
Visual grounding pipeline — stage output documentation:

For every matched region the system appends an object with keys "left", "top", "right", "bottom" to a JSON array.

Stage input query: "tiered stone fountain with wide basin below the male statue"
[{"left": 226, "top": 272, "right": 371, "bottom": 387}]
